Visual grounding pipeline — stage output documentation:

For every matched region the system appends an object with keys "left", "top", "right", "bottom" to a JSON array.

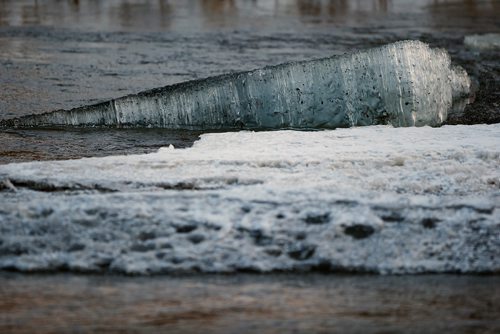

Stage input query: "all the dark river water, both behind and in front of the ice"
[{"left": 0, "top": 0, "right": 500, "bottom": 333}]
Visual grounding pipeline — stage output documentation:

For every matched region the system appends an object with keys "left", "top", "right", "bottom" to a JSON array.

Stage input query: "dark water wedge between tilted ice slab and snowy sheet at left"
[{"left": 0, "top": 128, "right": 201, "bottom": 164}]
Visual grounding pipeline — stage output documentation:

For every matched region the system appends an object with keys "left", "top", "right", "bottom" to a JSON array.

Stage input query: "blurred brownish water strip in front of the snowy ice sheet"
[{"left": 0, "top": 274, "right": 500, "bottom": 333}]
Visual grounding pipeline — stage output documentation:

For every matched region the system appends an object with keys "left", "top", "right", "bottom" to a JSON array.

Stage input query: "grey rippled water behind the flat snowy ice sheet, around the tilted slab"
[{"left": 0, "top": 0, "right": 500, "bottom": 163}]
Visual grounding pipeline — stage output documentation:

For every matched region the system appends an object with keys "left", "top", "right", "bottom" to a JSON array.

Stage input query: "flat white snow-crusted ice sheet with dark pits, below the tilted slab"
[{"left": 0, "top": 124, "right": 500, "bottom": 274}]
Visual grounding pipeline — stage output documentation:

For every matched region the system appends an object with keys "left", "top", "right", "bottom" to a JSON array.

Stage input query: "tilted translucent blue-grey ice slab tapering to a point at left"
[{"left": 0, "top": 41, "right": 470, "bottom": 129}]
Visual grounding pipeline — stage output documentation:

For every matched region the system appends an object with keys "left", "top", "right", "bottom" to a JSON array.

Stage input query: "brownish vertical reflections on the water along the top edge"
[{"left": 0, "top": 0, "right": 500, "bottom": 30}]
